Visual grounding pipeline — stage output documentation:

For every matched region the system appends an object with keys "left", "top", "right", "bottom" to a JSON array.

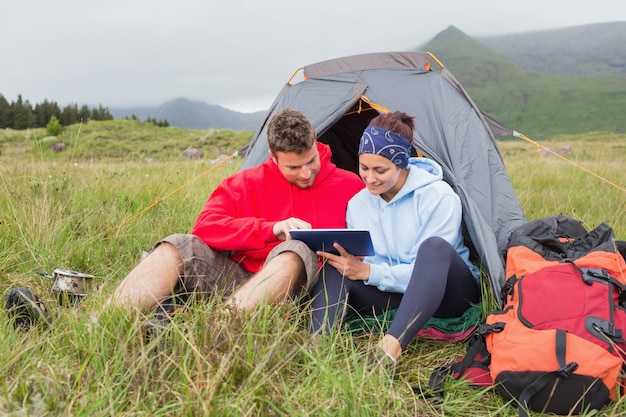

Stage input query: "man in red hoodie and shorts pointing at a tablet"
[{"left": 108, "top": 109, "right": 363, "bottom": 318}]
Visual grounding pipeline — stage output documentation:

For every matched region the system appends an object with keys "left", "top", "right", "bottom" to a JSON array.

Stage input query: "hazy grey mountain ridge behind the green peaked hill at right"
[{"left": 475, "top": 22, "right": 626, "bottom": 79}]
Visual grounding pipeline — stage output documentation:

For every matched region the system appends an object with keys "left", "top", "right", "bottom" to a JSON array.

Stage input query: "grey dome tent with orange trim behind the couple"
[{"left": 242, "top": 52, "right": 526, "bottom": 302}]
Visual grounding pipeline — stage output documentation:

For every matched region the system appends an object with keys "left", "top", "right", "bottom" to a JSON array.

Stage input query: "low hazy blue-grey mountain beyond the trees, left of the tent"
[{"left": 109, "top": 98, "right": 266, "bottom": 131}]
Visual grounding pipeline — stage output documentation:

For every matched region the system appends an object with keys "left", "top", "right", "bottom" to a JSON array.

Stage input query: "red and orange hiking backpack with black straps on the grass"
[{"left": 430, "top": 216, "right": 626, "bottom": 416}]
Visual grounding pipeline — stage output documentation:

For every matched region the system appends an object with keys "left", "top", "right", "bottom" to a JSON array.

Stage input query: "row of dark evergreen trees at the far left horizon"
[{"left": 0, "top": 94, "right": 113, "bottom": 130}]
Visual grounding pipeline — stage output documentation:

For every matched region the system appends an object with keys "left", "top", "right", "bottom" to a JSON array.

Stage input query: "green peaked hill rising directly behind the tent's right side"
[{"left": 418, "top": 26, "right": 626, "bottom": 139}]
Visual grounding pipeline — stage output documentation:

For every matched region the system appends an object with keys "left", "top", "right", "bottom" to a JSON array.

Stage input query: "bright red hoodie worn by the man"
[{"left": 191, "top": 142, "right": 364, "bottom": 273}]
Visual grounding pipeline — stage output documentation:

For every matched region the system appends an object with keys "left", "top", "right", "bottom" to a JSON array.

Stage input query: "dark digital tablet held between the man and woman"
[{"left": 289, "top": 229, "right": 374, "bottom": 256}]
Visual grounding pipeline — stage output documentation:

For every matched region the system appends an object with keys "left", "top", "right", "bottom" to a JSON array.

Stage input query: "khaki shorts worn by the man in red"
[{"left": 155, "top": 234, "right": 319, "bottom": 297}]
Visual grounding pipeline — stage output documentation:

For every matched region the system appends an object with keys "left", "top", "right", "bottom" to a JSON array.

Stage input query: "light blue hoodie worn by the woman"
[{"left": 346, "top": 158, "right": 478, "bottom": 293}]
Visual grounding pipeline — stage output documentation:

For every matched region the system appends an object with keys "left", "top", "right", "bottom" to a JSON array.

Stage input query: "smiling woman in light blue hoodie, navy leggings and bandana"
[{"left": 311, "top": 111, "right": 480, "bottom": 367}]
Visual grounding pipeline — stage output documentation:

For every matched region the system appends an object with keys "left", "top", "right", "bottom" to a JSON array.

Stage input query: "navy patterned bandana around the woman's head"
[{"left": 359, "top": 126, "right": 411, "bottom": 168}]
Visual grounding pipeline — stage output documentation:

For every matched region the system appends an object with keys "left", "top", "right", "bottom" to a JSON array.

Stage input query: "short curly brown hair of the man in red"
[{"left": 267, "top": 109, "right": 316, "bottom": 154}]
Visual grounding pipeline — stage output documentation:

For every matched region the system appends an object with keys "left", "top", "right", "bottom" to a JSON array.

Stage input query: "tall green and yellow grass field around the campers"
[{"left": 0, "top": 121, "right": 626, "bottom": 416}]
